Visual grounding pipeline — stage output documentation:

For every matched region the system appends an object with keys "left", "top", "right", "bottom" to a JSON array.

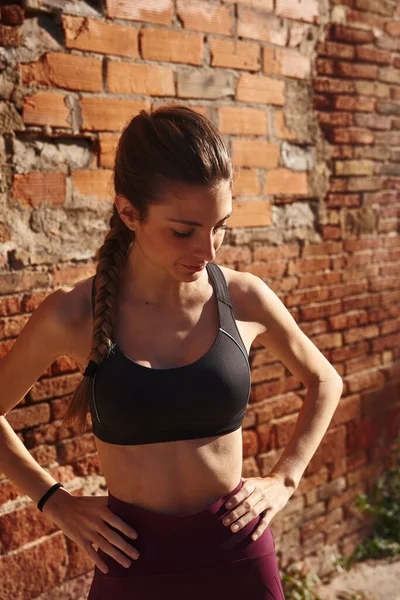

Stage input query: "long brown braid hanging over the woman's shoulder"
[{"left": 63, "top": 204, "right": 135, "bottom": 433}]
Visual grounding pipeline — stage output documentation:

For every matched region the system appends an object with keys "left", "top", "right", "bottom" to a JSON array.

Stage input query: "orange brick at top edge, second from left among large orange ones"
[{"left": 177, "top": 0, "right": 233, "bottom": 36}]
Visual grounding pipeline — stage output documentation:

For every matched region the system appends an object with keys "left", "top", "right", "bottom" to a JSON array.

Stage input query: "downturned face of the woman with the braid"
[{"left": 123, "top": 181, "right": 232, "bottom": 281}]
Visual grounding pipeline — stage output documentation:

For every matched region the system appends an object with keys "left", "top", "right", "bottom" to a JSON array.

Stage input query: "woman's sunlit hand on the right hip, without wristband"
[{"left": 222, "top": 475, "right": 294, "bottom": 540}]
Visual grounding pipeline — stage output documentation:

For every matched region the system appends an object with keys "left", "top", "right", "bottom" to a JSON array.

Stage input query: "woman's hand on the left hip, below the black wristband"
[{"left": 43, "top": 488, "right": 139, "bottom": 573}]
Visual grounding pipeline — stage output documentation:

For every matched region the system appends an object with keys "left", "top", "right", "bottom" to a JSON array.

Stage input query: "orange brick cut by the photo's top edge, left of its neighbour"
[{"left": 106, "top": 0, "right": 174, "bottom": 25}]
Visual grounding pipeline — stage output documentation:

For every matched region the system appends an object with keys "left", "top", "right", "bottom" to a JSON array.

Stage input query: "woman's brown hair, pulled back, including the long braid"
[{"left": 63, "top": 104, "right": 233, "bottom": 433}]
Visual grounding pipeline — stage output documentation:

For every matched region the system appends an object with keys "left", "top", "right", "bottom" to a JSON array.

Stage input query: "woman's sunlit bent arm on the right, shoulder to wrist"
[{"left": 241, "top": 273, "right": 343, "bottom": 491}]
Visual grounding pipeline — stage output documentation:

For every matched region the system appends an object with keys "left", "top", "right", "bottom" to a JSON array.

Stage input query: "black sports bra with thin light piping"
[{"left": 90, "top": 263, "right": 251, "bottom": 445}]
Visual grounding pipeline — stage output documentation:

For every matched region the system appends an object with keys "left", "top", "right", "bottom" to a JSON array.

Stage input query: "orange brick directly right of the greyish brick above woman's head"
[{"left": 236, "top": 73, "right": 285, "bottom": 106}]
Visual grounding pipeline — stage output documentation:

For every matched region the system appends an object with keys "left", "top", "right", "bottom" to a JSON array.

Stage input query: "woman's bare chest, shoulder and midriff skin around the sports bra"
[{"left": 64, "top": 268, "right": 260, "bottom": 514}]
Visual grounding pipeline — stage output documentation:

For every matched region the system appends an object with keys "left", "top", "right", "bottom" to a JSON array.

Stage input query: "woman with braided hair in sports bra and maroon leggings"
[{"left": 0, "top": 105, "right": 342, "bottom": 600}]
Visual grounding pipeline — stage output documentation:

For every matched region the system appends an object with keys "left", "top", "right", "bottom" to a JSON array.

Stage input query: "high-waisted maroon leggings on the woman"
[{"left": 88, "top": 479, "right": 285, "bottom": 600}]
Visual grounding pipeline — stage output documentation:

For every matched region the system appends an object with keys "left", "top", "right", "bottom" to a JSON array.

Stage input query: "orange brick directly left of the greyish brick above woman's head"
[{"left": 107, "top": 60, "right": 175, "bottom": 95}]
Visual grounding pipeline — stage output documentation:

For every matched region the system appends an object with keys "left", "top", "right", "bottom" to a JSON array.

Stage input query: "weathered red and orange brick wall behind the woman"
[{"left": 0, "top": 0, "right": 400, "bottom": 600}]
